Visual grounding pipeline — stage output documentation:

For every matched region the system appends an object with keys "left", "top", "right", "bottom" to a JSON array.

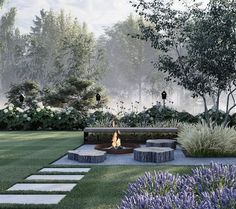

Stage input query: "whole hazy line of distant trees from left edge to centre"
[{"left": 0, "top": 1, "right": 170, "bottom": 111}]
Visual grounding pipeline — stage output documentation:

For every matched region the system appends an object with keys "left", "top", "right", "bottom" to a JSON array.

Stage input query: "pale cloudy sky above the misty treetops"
[{"left": 1, "top": 0, "right": 134, "bottom": 37}]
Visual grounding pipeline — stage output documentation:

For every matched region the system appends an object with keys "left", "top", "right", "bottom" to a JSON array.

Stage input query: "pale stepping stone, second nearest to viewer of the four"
[{"left": 7, "top": 183, "right": 76, "bottom": 192}]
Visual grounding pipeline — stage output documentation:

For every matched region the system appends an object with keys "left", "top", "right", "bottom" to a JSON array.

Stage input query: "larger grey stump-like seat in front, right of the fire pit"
[{"left": 134, "top": 147, "right": 174, "bottom": 163}]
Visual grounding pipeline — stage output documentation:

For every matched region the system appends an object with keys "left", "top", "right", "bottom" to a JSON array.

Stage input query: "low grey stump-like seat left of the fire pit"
[{"left": 68, "top": 150, "right": 106, "bottom": 163}]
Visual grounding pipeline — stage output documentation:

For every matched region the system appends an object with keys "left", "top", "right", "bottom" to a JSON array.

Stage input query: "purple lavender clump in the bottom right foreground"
[{"left": 117, "top": 163, "right": 236, "bottom": 209}]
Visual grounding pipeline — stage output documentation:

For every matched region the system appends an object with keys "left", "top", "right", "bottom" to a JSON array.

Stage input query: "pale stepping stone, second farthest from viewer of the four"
[{"left": 26, "top": 175, "right": 84, "bottom": 181}]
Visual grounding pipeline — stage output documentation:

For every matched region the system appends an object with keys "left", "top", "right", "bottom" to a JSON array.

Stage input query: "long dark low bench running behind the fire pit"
[{"left": 84, "top": 127, "right": 178, "bottom": 144}]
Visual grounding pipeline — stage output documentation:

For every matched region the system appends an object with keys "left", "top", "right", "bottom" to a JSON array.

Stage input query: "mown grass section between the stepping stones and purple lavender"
[{"left": 59, "top": 165, "right": 194, "bottom": 209}]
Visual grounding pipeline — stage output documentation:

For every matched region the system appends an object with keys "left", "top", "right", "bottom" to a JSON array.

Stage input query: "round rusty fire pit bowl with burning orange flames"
[{"left": 95, "top": 121, "right": 139, "bottom": 154}]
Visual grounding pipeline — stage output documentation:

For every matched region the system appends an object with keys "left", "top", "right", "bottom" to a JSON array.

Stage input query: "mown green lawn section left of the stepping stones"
[{"left": 0, "top": 131, "right": 83, "bottom": 192}]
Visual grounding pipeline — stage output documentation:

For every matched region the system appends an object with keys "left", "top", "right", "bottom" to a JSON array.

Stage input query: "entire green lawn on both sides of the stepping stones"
[{"left": 0, "top": 131, "right": 194, "bottom": 209}]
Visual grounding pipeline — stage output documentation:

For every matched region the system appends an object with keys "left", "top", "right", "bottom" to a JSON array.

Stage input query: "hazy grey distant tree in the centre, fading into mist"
[{"left": 99, "top": 16, "right": 169, "bottom": 104}]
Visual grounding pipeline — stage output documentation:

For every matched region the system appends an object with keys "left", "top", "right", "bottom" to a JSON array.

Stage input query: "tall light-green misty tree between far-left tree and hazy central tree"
[{"left": 21, "top": 10, "right": 104, "bottom": 87}]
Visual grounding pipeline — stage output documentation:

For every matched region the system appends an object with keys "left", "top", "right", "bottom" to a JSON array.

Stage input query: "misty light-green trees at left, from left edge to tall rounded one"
[{"left": 0, "top": 9, "right": 104, "bottom": 89}]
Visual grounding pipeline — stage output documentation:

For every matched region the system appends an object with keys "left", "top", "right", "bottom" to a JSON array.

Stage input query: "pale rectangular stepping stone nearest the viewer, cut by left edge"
[{"left": 0, "top": 194, "right": 66, "bottom": 205}]
